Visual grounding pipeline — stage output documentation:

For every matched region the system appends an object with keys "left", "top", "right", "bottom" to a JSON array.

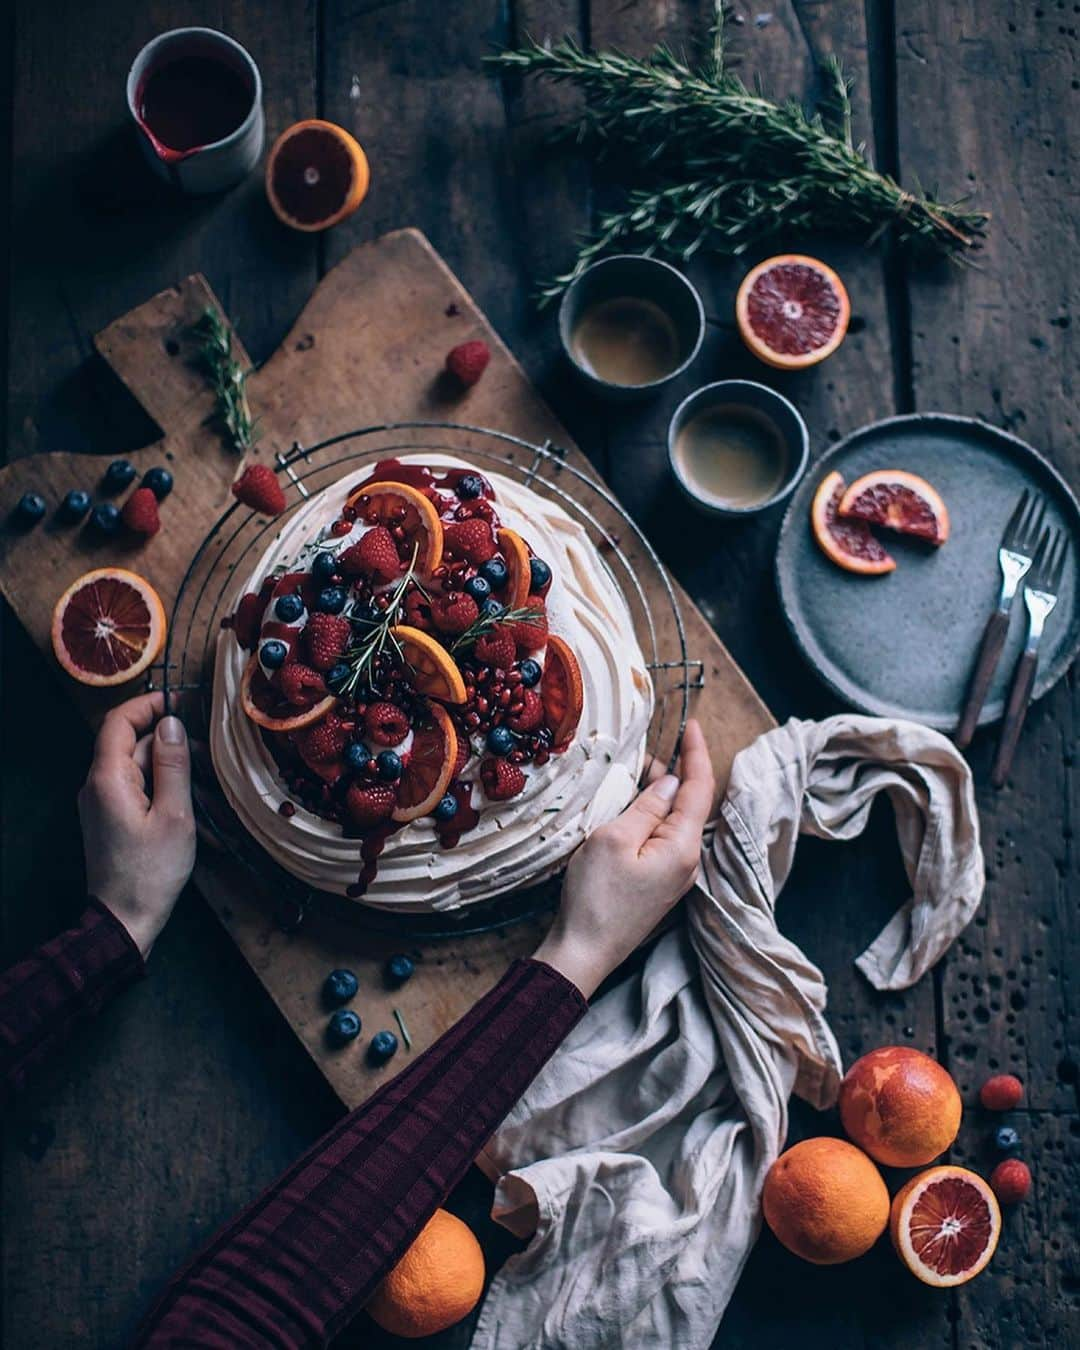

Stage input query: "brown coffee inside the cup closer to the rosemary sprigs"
[{"left": 570, "top": 296, "right": 682, "bottom": 385}]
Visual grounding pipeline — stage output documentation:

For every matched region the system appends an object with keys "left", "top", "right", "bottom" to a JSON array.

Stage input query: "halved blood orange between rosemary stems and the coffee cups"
[{"left": 734, "top": 254, "right": 852, "bottom": 370}]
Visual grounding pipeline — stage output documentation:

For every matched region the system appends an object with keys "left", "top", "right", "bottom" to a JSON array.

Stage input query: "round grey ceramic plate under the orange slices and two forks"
[{"left": 776, "top": 413, "right": 1080, "bottom": 732}]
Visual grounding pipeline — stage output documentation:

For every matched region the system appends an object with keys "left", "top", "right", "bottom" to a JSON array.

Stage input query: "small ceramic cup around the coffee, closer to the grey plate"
[{"left": 667, "top": 379, "right": 810, "bottom": 518}]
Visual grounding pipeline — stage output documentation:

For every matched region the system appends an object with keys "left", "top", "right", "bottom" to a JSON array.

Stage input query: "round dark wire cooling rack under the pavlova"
[{"left": 162, "top": 421, "right": 703, "bottom": 941}]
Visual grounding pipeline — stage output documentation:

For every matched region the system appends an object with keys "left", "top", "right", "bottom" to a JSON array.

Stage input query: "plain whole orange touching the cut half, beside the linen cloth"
[{"left": 761, "top": 1138, "right": 888, "bottom": 1265}]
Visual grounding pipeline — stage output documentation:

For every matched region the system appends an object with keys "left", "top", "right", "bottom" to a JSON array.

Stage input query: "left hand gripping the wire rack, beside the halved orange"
[{"left": 78, "top": 694, "right": 194, "bottom": 957}]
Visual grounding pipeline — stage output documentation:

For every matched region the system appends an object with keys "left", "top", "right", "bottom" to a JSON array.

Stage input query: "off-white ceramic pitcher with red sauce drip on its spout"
[{"left": 127, "top": 28, "right": 266, "bottom": 193}]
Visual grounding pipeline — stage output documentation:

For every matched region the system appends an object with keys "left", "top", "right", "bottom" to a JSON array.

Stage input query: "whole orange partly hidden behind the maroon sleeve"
[{"left": 367, "top": 1210, "right": 483, "bottom": 1339}]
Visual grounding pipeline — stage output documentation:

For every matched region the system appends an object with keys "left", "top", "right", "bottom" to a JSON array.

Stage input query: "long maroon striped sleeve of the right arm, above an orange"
[{"left": 135, "top": 961, "right": 586, "bottom": 1350}]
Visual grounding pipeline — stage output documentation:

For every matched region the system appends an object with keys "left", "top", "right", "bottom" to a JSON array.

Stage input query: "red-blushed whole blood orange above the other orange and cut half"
[{"left": 840, "top": 1045, "right": 961, "bottom": 1168}]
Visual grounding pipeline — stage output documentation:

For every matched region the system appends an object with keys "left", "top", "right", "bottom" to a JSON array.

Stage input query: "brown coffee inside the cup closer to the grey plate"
[{"left": 675, "top": 404, "right": 790, "bottom": 509}]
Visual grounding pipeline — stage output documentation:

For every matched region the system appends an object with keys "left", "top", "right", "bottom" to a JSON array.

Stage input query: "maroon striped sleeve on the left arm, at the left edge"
[{"left": 0, "top": 899, "right": 146, "bottom": 1100}]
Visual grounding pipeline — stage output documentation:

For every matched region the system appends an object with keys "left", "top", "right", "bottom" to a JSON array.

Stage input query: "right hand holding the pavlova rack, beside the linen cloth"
[{"left": 533, "top": 718, "right": 716, "bottom": 998}]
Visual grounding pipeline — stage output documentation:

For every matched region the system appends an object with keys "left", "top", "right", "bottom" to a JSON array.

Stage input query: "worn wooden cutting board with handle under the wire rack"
[{"left": 0, "top": 230, "right": 774, "bottom": 1106}]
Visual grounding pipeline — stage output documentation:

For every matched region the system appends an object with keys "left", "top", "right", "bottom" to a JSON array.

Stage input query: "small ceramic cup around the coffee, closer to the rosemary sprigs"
[{"left": 559, "top": 254, "right": 705, "bottom": 400}]
